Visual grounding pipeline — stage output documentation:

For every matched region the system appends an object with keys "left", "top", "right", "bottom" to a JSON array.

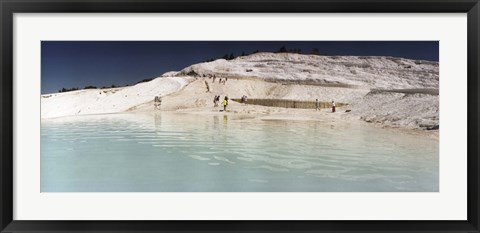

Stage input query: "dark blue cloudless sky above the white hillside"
[{"left": 41, "top": 41, "right": 439, "bottom": 94}]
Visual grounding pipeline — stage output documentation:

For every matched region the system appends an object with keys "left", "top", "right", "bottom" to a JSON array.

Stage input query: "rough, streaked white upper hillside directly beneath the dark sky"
[{"left": 169, "top": 53, "right": 439, "bottom": 89}]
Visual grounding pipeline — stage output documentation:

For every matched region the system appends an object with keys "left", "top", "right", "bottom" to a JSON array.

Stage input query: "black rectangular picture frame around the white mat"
[{"left": 0, "top": 0, "right": 480, "bottom": 232}]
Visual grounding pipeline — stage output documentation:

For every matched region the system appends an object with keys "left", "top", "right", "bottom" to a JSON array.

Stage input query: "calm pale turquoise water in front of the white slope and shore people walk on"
[{"left": 41, "top": 113, "right": 439, "bottom": 192}]
